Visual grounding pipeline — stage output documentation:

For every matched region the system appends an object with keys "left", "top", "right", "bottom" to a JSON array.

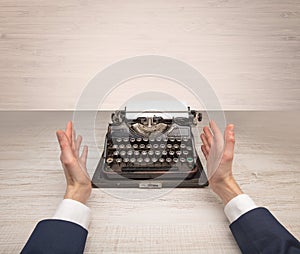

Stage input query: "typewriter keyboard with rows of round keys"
[{"left": 105, "top": 135, "right": 196, "bottom": 179}]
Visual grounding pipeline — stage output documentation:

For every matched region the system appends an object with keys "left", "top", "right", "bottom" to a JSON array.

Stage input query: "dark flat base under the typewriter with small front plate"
[{"left": 92, "top": 154, "right": 208, "bottom": 189}]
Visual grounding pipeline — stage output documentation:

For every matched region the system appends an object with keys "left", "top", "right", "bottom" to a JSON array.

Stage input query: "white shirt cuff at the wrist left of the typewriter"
[{"left": 52, "top": 199, "right": 91, "bottom": 230}]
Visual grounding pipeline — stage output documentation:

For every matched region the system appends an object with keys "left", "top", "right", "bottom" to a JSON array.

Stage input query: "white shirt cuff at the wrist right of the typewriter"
[{"left": 224, "top": 194, "right": 257, "bottom": 224}]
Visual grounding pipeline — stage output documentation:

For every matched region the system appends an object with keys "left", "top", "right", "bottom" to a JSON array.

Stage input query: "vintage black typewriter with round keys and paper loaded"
[{"left": 92, "top": 107, "right": 208, "bottom": 188}]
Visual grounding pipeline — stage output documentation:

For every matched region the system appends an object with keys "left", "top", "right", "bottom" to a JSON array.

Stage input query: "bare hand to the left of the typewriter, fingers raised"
[{"left": 56, "top": 121, "right": 92, "bottom": 204}]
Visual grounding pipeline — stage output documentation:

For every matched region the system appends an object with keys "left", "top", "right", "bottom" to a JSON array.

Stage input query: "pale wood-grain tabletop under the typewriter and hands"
[{"left": 0, "top": 111, "right": 300, "bottom": 253}]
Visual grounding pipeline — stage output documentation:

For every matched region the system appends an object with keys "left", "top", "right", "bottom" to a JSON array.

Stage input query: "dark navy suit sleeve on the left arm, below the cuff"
[{"left": 21, "top": 219, "right": 88, "bottom": 254}]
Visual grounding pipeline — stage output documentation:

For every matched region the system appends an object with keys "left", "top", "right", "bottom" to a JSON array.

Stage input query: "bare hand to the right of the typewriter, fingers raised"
[{"left": 201, "top": 121, "right": 242, "bottom": 204}]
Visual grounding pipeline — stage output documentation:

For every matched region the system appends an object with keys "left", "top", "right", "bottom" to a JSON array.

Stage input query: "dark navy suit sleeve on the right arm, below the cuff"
[{"left": 230, "top": 207, "right": 300, "bottom": 254}]
